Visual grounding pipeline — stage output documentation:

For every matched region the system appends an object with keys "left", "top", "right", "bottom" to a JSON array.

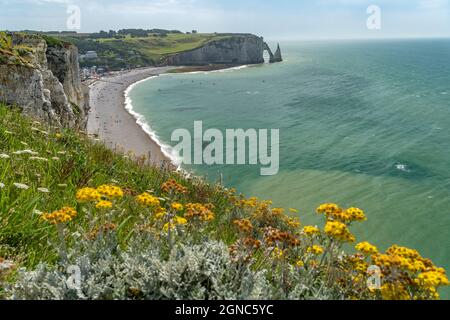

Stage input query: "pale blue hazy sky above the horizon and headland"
[{"left": 0, "top": 0, "right": 450, "bottom": 40}]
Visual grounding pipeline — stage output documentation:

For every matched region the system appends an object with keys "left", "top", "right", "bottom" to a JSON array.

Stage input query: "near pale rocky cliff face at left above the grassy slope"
[{"left": 0, "top": 34, "right": 89, "bottom": 129}]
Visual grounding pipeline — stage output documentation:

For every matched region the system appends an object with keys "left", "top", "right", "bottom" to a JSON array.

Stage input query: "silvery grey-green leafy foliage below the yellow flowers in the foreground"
[{"left": 7, "top": 235, "right": 271, "bottom": 300}]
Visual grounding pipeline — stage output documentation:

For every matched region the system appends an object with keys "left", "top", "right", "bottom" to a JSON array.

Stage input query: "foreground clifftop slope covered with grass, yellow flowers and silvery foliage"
[{"left": 0, "top": 105, "right": 449, "bottom": 299}]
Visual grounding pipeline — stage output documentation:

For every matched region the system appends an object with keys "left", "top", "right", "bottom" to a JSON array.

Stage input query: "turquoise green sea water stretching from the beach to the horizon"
[{"left": 130, "top": 40, "right": 450, "bottom": 298}]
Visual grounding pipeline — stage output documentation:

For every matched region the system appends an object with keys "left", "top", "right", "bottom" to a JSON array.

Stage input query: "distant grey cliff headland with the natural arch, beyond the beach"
[{"left": 167, "top": 34, "right": 281, "bottom": 66}]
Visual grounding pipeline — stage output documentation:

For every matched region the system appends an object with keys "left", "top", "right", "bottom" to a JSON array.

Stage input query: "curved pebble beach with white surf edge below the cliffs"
[{"left": 87, "top": 65, "right": 247, "bottom": 168}]
